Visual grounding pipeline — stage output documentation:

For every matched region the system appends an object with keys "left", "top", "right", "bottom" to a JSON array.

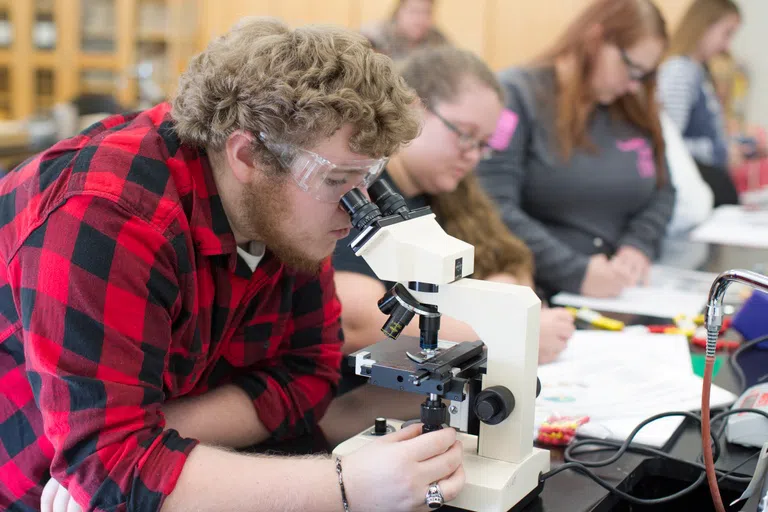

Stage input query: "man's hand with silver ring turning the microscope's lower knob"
[{"left": 342, "top": 424, "right": 464, "bottom": 512}]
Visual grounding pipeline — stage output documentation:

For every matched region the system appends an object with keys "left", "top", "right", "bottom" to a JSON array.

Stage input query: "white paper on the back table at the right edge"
[{"left": 691, "top": 205, "right": 768, "bottom": 248}]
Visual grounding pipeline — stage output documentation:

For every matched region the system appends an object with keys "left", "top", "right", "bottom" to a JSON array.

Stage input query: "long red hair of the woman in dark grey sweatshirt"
[{"left": 535, "top": 0, "right": 667, "bottom": 184}]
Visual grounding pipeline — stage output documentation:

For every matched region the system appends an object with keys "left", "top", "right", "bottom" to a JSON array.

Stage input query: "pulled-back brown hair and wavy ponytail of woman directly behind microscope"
[{"left": 400, "top": 45, "right": 533, "bottom": 281}]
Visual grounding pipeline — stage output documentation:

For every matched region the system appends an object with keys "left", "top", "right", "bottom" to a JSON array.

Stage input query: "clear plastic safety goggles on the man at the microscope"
[{"left": 259, "top": 133, "right": 388, "bottom": 203}]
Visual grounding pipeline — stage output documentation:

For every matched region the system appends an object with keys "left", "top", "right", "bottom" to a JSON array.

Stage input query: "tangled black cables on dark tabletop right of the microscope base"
[{"left": 539, "top": 406, "right": 768, "bottom": 505}]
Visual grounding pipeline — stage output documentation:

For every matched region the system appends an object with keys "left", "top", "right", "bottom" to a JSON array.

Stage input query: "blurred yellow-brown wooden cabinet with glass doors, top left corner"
[{"left": 0, "top": 0, "right": 202, "bottom": 119}]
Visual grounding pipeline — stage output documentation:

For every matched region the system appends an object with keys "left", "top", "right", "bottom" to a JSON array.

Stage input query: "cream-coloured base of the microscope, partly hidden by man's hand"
[{"left": 333, "top": 420, "right": 549, "bottom": 512}]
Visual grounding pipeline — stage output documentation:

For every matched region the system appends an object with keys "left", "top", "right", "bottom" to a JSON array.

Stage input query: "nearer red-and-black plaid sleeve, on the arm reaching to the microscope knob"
[{"left": 8, "top": 195, "right": 196, "bottom": 511}]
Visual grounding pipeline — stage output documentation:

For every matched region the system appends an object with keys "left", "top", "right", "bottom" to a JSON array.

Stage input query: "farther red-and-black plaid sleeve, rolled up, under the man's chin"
[{"left": 234, "top": 259, "right": 344, "bottom": 440}]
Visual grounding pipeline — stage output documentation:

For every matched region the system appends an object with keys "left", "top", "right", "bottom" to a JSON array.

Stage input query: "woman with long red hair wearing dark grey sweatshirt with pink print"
[{"left": 478, "top": 0, "right": 675, "bottom": 297}]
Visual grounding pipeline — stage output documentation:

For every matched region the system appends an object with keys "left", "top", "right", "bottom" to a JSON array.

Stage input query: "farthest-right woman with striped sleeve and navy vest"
[{"left": 659, "top": 0, "right": 744, "bottom": 206}]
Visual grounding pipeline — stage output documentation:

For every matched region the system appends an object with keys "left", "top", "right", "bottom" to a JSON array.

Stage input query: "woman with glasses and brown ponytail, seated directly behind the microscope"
[{"left": 321, "top": 46, "right": 574, "bottom": 443}]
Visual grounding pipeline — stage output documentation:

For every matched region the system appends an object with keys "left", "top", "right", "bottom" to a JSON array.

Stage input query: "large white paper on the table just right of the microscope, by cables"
[{"left": 536, "top": 331, "right": 736, "bottom": 447}]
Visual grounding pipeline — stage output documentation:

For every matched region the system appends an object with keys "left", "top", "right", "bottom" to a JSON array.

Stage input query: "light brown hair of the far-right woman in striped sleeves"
[{"left": 668, "top": 0, "right": 741, "bottom": 56}]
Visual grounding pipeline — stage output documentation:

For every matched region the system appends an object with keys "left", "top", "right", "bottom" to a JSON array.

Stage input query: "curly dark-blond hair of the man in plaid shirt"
[{"left": 172, "top": 18, "right": 420, "bottom": 159}]
